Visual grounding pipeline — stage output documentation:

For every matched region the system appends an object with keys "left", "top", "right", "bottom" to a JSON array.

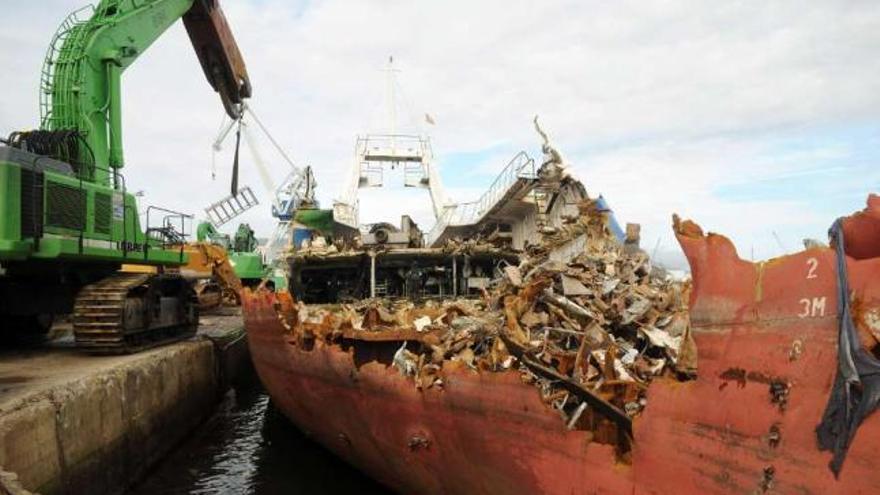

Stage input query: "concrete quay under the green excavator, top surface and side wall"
[{"left": 0, "top": 308, "right": 250, "bottom": 495}]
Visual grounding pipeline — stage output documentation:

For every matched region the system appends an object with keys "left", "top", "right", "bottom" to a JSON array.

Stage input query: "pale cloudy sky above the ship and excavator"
[{"left": 0, "top": 0, "right": 880, "bottom": 268}]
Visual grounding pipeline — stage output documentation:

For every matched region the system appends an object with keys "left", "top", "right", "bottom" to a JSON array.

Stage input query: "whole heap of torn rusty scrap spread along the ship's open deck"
[{"left": 278, "top": 159, "right": 697, "bottom": 458}]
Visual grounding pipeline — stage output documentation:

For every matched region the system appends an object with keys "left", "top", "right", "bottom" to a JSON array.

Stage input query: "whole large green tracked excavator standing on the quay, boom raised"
[{"left": 0, "top": 0, "right": 251, "bottom": 353}]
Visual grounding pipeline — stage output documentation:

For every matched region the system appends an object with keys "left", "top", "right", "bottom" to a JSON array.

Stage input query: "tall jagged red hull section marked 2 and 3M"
[{"left": 633, "top": 196, "right": 880, "bottom": 495}]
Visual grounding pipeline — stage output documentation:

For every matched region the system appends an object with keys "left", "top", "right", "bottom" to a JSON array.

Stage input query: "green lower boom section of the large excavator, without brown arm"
[{"left": 40, "top": 0, "right": 193, "bottom": 185}]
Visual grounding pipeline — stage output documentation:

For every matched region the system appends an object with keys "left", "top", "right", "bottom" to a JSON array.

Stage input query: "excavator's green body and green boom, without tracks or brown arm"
[{"left": 0, "top": 0, "right": 210, "bottom": 322}]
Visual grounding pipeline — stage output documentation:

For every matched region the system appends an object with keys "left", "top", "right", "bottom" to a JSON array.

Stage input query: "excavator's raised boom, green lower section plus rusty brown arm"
[{"left": 41, "top": 0, "right": 251, "bottom": 184}]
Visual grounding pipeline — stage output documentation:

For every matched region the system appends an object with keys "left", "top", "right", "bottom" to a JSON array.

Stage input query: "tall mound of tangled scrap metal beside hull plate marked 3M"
[{"left": 495, "top": 200, "right": 697, "bottom": 442}]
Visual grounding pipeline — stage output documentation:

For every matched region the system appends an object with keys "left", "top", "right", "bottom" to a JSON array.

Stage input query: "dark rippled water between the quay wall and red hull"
[{"left": 127, "top": 379, "right": 390, "bottom": 495}]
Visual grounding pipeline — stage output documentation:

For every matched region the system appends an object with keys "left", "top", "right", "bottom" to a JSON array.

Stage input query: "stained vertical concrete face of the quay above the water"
[{"left": 0, "top": 340, "right": 221, "bottom": 495}]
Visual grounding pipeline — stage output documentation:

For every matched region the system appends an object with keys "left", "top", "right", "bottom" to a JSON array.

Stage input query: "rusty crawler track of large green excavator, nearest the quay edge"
[{"left": 73, "top": 272, "right": 199, "bottom": 354}]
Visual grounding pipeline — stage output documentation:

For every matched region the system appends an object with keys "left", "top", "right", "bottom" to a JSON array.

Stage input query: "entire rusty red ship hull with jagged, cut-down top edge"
[{"left": 244, "top": 196, "right": 880, "bottom": 494}]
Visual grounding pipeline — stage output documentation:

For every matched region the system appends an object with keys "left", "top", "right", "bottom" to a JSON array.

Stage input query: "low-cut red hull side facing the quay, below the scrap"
[{"left": 243, "top": 290, "right": 631, "bottom": 494}]
